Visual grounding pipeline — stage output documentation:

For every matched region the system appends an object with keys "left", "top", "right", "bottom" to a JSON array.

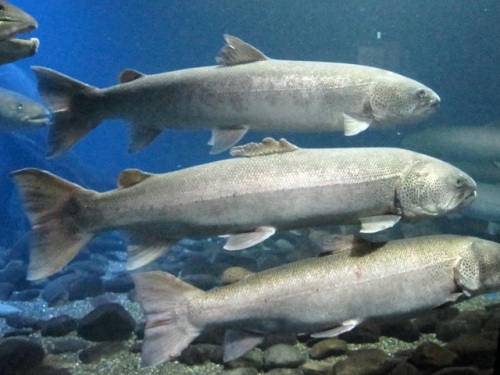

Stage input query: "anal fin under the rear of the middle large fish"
[{"left": 127, "top": 232, "right": 176, "bottom": 271}]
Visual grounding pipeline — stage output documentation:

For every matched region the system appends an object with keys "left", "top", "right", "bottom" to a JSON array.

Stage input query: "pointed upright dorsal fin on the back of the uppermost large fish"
[{"left": 215, "top": 34, "right": 268, "bottom": 66}]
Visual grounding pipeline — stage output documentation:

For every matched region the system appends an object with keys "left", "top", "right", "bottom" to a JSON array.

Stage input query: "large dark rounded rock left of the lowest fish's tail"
[{"left": 77, "top": 303, "right": 135, "bottom": 342}]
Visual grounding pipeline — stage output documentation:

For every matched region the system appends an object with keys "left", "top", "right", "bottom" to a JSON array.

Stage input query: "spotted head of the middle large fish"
[{"left": 397, "top": 158, "right": 476, "bottom": 220}]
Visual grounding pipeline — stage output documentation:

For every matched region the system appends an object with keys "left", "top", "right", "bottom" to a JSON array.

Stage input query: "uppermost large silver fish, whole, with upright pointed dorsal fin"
[{"left": 32, "top": 34, "right": 441, "bottom": 156}]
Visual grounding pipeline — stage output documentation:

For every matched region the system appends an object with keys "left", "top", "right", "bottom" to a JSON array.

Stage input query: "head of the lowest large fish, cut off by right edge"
[{"left": 454, "top": 238, "right": 500, "bottom": 295}]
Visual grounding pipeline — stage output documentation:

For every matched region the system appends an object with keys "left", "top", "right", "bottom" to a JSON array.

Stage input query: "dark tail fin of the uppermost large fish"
[{"left": 31, "top": 66, "right": 101, "bottom": 157}]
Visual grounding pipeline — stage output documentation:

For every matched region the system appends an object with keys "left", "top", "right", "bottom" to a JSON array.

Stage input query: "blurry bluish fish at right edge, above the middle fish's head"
[{"left": 401, "top": 122, "right": 500, "bottom": 163}]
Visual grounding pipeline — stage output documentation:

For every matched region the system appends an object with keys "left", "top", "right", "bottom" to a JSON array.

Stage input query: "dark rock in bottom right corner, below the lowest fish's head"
[{"left": 446, "top": 334, "right": 497, "bottom": 368}]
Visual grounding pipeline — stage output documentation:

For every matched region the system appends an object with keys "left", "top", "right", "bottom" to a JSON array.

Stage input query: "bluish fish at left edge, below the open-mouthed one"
[{"left": 0, "top": 88, "right": 50, "bottom": 131}]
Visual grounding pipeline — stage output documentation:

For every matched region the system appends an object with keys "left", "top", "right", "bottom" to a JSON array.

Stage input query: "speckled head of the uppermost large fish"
[{"left": 370, "top": 72, "right": 441, "bottom": 125}]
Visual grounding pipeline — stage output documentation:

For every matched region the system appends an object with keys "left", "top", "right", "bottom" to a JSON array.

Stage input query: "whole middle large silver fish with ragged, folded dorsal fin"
[{"left": 11, "top": 138, "right": 476, "bottom": 280}]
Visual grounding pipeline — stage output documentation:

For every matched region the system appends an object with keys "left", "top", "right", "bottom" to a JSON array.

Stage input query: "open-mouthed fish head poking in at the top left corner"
[{"left": 0, "top": 0, "right": 40, "bottom": 65}]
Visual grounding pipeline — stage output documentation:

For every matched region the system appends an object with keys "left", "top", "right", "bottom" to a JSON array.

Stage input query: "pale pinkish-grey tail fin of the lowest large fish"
[{"left": 132, "top": 272, "right": 205, "bottom": 367}]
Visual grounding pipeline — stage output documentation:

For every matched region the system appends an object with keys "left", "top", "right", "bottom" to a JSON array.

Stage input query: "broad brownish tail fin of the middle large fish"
[{"left": 11, "top": 169, "right": 96, "bottom": 280}]
